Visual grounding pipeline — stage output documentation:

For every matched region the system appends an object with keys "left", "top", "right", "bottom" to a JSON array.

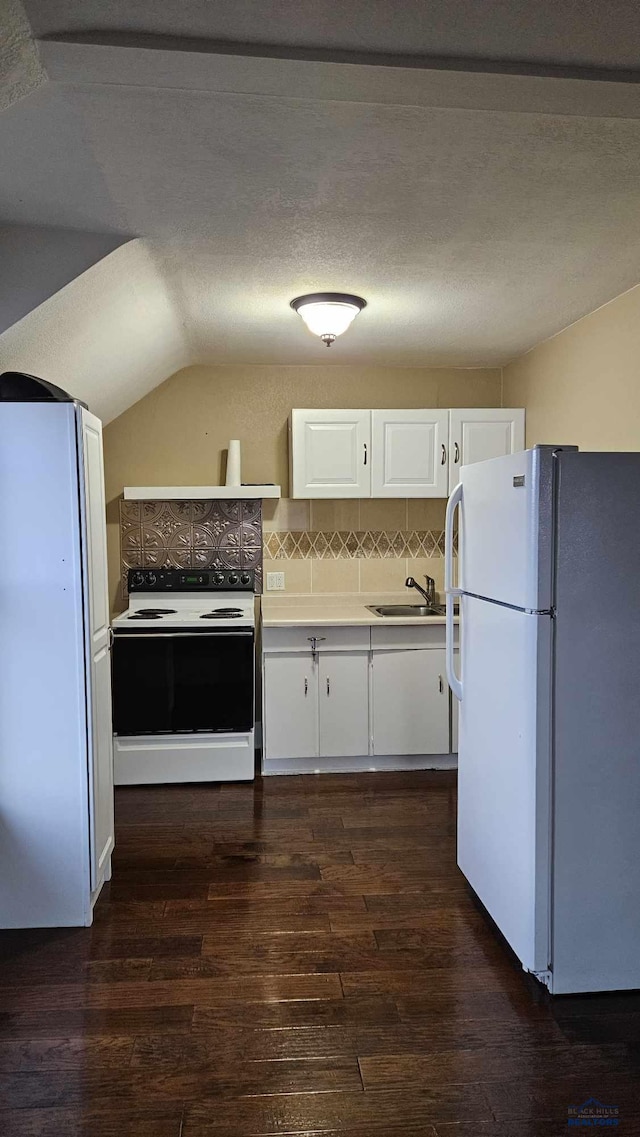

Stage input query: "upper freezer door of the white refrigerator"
[{"left": 458, "top": 447, "right": 554, "bottom": 612}]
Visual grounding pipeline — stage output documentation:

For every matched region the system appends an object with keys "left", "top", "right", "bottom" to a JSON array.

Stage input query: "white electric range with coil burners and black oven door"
[{"left": 113, "top": 569, "right": 256, "bottom": 786}]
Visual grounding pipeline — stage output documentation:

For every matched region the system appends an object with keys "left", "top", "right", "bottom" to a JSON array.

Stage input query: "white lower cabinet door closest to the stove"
[{"left": 263, "top": 652, "right": 318, "bottom": 758}]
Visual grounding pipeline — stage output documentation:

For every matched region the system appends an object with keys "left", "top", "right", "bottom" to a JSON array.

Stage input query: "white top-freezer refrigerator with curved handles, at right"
[{"left": 446, "top": 446, "right": 640, "bottom": 994}]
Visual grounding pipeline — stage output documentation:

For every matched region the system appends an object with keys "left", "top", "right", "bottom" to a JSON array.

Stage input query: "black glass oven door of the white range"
[{"left": 113, "top": 628, "right": 255, "bottom": 735}]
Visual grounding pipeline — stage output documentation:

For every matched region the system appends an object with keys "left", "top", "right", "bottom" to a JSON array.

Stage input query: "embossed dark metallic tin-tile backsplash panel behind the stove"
[{"left": 120, "top": 499, "right": 263, "bottom": 599}]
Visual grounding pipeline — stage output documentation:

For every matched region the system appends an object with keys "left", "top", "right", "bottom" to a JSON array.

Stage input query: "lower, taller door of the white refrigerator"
[{"left": 458, "top": 596, "right": 552, "bottom": 971}]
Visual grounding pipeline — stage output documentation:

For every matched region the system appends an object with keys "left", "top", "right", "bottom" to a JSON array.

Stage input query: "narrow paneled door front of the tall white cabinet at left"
[{"left": 82, "top": 410, "right": 115, "bottom": 888}]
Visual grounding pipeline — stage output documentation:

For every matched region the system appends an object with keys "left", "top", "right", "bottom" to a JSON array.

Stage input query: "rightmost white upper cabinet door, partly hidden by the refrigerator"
[{"left": 449, "top": 407, "right": 524, "bottom": 492}]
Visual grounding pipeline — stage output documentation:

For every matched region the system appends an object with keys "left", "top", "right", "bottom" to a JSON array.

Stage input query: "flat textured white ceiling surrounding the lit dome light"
[{"left": 0, "top": 0, "right": 640, "bottom": 413}]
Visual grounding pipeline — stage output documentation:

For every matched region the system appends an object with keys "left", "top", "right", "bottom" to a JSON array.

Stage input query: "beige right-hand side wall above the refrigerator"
[{"left": 502, "top": 279, "right": 640, "bottom": 450}]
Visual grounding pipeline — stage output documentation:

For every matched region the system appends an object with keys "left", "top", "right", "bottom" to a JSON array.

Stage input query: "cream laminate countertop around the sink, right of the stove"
[{"left": 261, "top": 591, "right": 458, "bottom": 628}]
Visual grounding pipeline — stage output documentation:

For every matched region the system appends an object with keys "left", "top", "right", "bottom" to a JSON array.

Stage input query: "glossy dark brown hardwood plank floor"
[{"left": 0, "top": 773, "right": 640, "bottom": 1137}]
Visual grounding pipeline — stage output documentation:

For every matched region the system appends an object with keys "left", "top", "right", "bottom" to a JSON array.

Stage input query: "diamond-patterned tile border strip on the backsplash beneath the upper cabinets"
[{"left": 264, "top": 529, "right": 444, "bottom": 561}]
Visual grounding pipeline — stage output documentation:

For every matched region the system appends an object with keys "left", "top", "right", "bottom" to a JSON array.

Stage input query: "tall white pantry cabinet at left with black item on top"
[{"left": 0, "top": 388, "right": 114, "bottom": 928}]
